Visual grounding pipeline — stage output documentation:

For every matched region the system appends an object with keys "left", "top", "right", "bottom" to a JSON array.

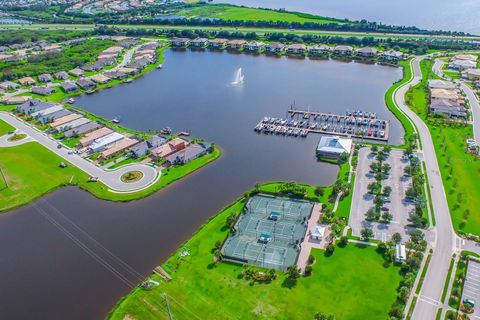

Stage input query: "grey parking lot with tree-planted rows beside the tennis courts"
[{"left": 348, "top": 148, "right": 414, "bottom": 241}]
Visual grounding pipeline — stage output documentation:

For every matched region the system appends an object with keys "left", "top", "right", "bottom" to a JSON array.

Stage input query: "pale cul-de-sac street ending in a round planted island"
[{"left": 0, "top": 112, "right": 159, "bottom": 192}]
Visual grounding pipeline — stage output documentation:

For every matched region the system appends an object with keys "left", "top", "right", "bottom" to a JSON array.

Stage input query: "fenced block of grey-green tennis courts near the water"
[{"left": 222, "top": 195, "right": 313, "bottom": 270}]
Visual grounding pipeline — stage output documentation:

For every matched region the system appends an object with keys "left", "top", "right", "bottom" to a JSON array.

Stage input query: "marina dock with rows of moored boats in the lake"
[{"left": 254, "top": 108, "right": 390, "bottom": 141}]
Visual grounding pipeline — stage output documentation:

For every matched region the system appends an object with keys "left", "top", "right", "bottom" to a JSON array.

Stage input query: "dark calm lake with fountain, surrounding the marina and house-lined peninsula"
[{"left": 0, "top": 51, "right": 403, "bottom": 319}]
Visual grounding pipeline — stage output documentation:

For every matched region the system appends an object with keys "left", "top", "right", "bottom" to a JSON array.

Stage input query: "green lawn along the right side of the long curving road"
[{"left": 405, "top": 61, "right": 480, "bottom": 235}]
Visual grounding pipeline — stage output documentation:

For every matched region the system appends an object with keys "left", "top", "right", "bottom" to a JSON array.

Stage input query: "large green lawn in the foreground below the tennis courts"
[{"left": 109, "top": 196, "right": 401, "bottom": 320}]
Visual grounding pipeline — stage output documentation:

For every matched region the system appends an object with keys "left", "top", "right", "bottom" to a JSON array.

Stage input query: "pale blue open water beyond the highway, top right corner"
[{"left": 214, "top": 0, "right": 480, "bottom": 34}]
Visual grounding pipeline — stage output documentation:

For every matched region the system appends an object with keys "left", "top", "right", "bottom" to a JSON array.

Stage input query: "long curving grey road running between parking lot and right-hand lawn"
[{"left": 394, "top": 57, "right": 457, "bottom": 320}]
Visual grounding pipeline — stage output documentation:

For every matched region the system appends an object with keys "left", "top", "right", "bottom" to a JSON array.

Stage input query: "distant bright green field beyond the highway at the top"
[{"left": 177, "top": 4, "right": 341, "bottom": 24}]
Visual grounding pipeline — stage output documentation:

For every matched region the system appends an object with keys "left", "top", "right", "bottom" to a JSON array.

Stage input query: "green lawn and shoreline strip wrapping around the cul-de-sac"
[{"left": 0, "top": 142, "right": 221, "bottom": 211}]
